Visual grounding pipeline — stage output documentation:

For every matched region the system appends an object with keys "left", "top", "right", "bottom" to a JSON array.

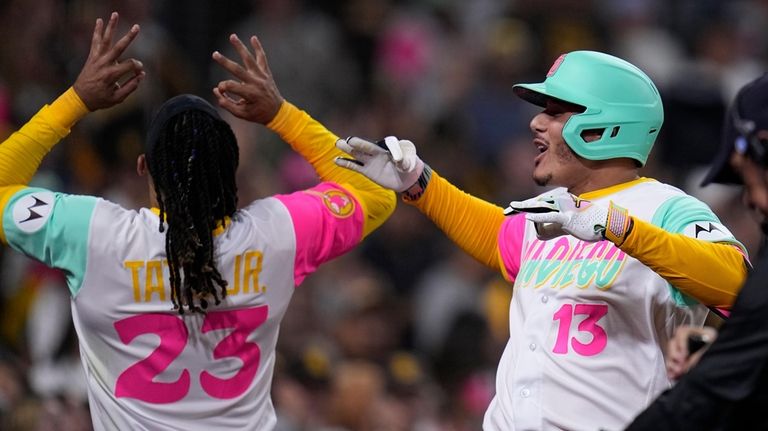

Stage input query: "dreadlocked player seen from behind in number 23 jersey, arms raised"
[{"left": 0, "top": 14, "right": 395, "bottom": 431}]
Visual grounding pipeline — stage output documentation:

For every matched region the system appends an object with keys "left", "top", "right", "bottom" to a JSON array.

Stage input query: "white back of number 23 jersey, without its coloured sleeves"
[{"left": 72, "top": 198, "right": 295, "bottom": 431}]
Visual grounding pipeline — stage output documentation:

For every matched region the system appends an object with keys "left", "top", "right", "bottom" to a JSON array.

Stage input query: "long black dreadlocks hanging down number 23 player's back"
[{"left": 148, "top": 110, "right": 239, "bottom": 314}]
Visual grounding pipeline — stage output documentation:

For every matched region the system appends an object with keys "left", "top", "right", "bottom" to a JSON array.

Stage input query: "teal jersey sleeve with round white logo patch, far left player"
[{"left": 3, "top": 188, "right": 98, "bottom": 296}]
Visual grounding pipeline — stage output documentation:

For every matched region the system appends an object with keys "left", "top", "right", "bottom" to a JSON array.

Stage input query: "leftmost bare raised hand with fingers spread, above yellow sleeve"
[{"left": 73, "top": 12, "right": 145, "bottom": 111}]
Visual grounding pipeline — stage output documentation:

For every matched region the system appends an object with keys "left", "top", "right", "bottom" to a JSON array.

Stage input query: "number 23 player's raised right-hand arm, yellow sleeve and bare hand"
[{"left": 213, "top": 35, "right": 396, "bottom": 236}]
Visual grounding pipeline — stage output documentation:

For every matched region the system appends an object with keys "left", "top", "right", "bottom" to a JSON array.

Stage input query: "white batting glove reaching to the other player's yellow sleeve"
[{"left": 335, "top": 136, "right": 424, "bottom": 193}]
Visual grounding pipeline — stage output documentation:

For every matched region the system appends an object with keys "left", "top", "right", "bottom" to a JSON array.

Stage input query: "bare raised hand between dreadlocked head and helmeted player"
[{"left": 213, "top": 34, "right": 283, "bottom": 124}]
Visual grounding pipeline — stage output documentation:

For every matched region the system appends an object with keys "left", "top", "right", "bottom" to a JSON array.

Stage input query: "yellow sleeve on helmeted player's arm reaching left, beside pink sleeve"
[{"left": 405, "top": 171, "right": 505, "bottom": 270}]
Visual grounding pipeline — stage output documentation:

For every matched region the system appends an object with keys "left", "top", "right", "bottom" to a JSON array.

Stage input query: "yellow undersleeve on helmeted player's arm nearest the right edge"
[{"left": 619, "top": 217, "right": 747, "bottom": 308}]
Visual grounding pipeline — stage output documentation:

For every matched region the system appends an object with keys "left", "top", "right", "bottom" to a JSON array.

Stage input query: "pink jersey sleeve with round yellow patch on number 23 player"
[{"left": 275, "top": 182, "right": 364, "bottom": 286}]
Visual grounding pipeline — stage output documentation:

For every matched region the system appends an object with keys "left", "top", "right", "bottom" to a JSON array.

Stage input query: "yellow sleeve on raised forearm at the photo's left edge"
[{"left": 0, "top": 87, "right": 88, "bottom": 186}]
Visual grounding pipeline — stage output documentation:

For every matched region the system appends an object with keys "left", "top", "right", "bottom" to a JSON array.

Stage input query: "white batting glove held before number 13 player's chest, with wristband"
[{"left": 504, "top": 191, "right": 631, "bottom": 245}]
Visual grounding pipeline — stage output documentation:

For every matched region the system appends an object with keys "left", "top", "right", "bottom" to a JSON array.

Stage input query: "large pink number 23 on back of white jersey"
[{"left": 115, "top": 305, "right": 268, "bottom": 404}]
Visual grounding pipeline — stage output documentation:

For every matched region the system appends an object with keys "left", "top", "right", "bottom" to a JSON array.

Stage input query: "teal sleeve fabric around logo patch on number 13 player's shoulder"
[{"left": 651, "top": 195, "right": 746, "bottom": 306}]
